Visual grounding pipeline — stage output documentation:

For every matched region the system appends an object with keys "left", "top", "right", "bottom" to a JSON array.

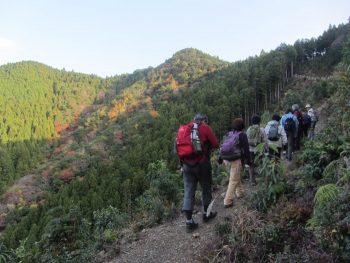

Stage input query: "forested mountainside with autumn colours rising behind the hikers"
[{"left": 0, "top": 24, "right": 350, "bottom": 262}]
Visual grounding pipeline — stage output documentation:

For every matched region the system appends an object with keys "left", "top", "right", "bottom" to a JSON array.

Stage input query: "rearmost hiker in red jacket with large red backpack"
[{"left": 176, "top": 113, "right": 219, "bottom": 232}]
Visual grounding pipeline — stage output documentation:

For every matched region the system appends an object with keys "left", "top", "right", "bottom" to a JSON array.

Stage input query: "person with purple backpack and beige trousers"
[{"left": 220, "top": 118, "right": 251, "bottom": 208}]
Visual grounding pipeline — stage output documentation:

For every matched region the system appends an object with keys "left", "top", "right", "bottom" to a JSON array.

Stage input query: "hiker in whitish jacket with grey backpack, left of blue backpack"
[{"left": 265, "top": 113, "right": 287, "bottom": 159}]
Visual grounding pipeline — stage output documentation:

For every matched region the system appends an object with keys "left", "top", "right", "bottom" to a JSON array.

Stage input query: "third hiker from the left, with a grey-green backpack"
[{"left": 247, "top": 115, "right": 267, "bottom": 186}]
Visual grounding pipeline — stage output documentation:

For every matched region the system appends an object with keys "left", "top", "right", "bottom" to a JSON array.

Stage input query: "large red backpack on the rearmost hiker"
[{"left": 175, "top": 123, "right": 202, "bottom": 158}]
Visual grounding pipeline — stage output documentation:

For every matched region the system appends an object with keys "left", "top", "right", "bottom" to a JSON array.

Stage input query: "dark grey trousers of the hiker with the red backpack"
[{"left": 182, "top": 162, "right": 212, "bottom": 211}]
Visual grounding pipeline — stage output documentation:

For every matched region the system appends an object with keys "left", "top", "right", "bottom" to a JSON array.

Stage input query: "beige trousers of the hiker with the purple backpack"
[{"left": 224, "top": 160, "right": 244, "bottom": 205}]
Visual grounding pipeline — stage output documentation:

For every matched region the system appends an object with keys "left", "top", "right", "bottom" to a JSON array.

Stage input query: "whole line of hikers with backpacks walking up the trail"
[{"left": 176, "top": 104, "right": 318, "bottom": 232}]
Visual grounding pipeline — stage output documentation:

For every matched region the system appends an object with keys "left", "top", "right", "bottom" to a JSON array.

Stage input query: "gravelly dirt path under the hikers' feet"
[{"left": 104, "top": 185, "right": 249, "bottom": 263}]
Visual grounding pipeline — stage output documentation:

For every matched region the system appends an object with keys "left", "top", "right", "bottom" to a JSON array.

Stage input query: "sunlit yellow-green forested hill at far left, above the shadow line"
[{"left": 0, "top": 61, "right": 105, "bottom": 143}]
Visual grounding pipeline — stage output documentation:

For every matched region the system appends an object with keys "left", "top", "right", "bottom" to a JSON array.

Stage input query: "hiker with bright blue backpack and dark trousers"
[{"left": 281, "top": 108, "right": 299, "bottom": 161}]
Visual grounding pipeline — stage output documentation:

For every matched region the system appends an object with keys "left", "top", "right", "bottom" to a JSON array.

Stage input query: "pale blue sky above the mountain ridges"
[{"left": 0, "top": 0, "right": 350, "bottom": 77}]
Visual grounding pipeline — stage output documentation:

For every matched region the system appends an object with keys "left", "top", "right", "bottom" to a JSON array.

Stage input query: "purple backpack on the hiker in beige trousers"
[{"left": 220, "top": 131, "right": 241, "bottom": 161}]
